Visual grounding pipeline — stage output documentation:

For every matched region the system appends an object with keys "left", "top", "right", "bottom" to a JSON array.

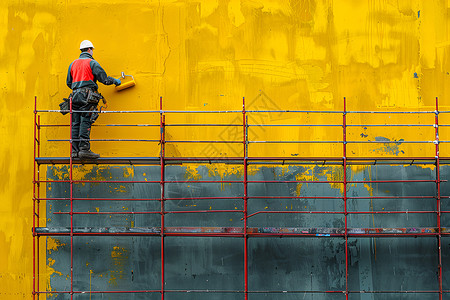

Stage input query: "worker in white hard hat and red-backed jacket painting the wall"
[{"left": 66, "top": 40, "right": 121, "bottom": 159}]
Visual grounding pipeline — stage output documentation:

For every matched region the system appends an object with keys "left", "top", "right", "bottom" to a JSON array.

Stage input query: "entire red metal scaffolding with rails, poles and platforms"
[{"left": 32, "top": 97, "right": 450, "bottom": 300}]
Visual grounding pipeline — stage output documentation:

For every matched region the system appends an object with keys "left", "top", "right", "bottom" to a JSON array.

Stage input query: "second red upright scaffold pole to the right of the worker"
[{"left": 242, "top": 97, "right": 248, "bottom": 300}]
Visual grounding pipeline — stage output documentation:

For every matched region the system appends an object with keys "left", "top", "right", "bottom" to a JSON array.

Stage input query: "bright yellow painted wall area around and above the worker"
[{"left": 0, "top": 0, "right": 450, "bottom": 299}]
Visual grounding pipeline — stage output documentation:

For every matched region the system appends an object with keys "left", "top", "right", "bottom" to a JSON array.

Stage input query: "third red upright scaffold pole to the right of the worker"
[{"left": 342, "top": 97, "right": 348, "bottom": 300}]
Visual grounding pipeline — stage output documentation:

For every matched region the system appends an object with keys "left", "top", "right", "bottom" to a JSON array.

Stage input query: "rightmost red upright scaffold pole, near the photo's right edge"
[{"left": 434, "top": 97, "right": 442, "bottom": 300}]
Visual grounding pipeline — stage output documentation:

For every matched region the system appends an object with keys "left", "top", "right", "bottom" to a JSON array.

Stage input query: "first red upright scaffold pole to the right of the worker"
[{"left": 159, "top": 97, "right": 165, "bottom": 300}]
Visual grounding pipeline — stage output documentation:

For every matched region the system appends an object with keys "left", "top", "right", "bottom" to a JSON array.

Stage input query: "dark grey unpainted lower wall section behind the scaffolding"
[{"left": 47, "top": 165, "right": 450, "bottom": 300}]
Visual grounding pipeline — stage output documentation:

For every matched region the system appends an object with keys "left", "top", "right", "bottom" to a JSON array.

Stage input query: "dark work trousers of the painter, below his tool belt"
[{"left": 72, "top": 112, "right": 93, "bottom": 152}]
